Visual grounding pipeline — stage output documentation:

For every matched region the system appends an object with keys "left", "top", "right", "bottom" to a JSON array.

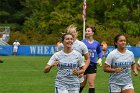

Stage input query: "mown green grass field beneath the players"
[{"left": 0, "top": 56, "right": 140, "bottom": 93}]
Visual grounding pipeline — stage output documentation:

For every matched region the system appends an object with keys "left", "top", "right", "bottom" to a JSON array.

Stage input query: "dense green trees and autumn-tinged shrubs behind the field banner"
[{"left": 0, "top": 0, "right": 140, "bottom": 45}]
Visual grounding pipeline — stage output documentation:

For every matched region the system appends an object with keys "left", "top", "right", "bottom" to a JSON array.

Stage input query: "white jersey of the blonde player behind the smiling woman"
[{"left": 58, "top": 40, "right": 88, "bottom": 55}]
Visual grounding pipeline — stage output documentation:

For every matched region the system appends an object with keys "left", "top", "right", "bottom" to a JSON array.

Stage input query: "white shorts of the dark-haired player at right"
[{"left": 110, "top": 84, "right": 134, "bottom": 93}]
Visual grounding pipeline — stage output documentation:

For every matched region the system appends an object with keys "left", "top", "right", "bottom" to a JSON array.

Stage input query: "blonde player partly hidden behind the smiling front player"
[{"left": 58, "top": 24, "right": 90, "bottom": 74}]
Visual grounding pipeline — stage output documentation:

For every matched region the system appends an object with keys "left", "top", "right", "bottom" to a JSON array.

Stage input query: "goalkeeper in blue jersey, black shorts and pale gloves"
[{"left": 80, "top": 27, "right": 102, "bottom": 93}]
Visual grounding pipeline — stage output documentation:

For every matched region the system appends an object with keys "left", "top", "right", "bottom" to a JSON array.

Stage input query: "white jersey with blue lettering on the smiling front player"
[{"left": 48, "top": 50, "right": 85, "bottom": 90}]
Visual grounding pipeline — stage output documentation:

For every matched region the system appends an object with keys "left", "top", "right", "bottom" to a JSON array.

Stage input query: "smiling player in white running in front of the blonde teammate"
[{"left": 44, "top": 33, "right": 85, "bottom": 93}]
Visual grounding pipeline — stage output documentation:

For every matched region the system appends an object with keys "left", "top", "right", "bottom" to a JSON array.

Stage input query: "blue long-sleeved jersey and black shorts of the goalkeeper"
[{"left": 82, "top": 39, "right": 102, "bottom": 75}]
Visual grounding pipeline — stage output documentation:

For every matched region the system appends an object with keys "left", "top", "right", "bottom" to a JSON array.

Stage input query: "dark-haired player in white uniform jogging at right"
[{"left": 104, "top": 34, "right": 138, "bottom": 93}]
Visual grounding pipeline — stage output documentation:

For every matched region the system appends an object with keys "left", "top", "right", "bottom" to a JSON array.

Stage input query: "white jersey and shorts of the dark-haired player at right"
[{"left": 105, "top": 49, "right": 135, "bottom": 92}]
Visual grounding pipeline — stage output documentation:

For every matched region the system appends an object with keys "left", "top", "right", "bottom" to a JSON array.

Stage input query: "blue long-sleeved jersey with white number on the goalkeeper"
[{"left": 82, "top": 39, "right": 102, "bottom": 66}]
